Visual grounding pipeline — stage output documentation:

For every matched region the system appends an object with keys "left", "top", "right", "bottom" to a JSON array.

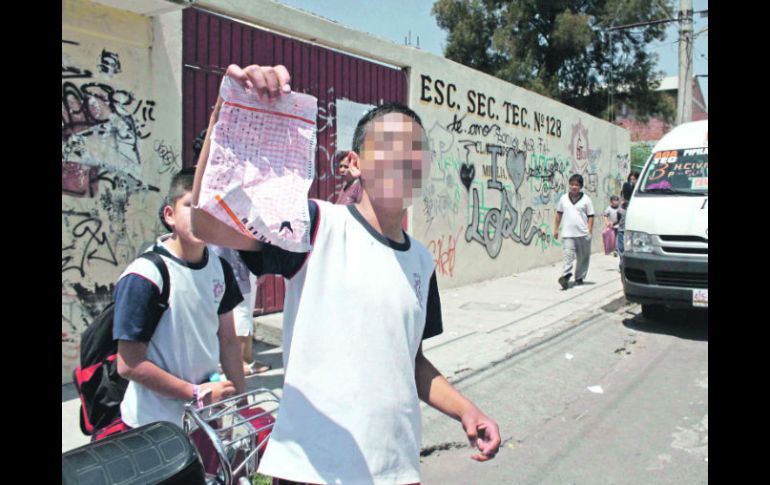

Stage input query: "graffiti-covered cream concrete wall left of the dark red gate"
[{"left": 62, "top": 0, "right": 182, "bottom": 383}]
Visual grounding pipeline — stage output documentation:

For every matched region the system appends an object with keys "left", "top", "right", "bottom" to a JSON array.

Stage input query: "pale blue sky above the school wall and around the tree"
[{"left": 277, "top": 0, "right": 708, "bottom": 108}]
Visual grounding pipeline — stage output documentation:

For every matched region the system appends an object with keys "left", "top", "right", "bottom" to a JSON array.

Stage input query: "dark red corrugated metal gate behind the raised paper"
[{"left": 182, "top": 8, "right": 407, "bottom": 314}]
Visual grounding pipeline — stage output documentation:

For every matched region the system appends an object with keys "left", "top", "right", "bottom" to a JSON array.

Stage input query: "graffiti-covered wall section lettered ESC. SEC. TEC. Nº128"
[{"left": 410, "top": 61, "right": 629, "bottom": 287}]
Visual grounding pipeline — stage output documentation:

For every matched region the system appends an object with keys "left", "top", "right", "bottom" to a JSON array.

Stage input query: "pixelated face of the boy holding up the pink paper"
[{"left": 359, "top": 113, "right": 431, "bottom": 209}]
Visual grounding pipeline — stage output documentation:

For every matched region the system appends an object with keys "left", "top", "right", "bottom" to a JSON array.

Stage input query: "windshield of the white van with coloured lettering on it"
[{"left": 637, "top": 147, "right": 709, "bottom": 195}]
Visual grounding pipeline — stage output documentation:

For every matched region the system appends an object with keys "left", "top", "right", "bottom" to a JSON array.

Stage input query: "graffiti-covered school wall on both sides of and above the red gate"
[{"left": 62, "top": 0, "right": 629, "bottom": 382}]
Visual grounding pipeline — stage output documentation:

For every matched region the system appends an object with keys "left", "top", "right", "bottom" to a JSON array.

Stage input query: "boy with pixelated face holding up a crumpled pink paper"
[{"left": 187, "top": 65, "right": 500, "bottom": 485}]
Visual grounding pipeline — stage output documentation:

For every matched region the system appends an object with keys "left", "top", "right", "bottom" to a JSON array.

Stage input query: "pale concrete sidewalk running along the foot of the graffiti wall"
[{"left": 62, "top": 252, "right": 623, "bottom": 452}]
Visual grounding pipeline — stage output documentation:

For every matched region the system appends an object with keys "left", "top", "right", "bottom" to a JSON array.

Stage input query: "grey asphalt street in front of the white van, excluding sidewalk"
[{"left": 416, "top": 304, "right": 708, "bottom": 484}]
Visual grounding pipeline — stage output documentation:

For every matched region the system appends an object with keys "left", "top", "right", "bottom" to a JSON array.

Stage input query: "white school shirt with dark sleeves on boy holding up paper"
[{"left": 241, "top": 201, "right": 442, "bottom": 485}]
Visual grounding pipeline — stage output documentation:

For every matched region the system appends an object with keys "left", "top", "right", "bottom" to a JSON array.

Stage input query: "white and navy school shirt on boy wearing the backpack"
[{"left": 113, "top": 235, "right": 243, "bottom": 427}]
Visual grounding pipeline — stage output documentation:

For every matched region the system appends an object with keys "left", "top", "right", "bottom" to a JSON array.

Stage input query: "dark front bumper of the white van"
[{"left": 621, "top": 253, "right": 709, "bottom": 308}]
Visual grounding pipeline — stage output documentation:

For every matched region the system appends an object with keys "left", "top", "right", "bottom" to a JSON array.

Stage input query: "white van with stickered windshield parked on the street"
[{"left": 621, "top": 120, "right": 709, "bottom": 318}]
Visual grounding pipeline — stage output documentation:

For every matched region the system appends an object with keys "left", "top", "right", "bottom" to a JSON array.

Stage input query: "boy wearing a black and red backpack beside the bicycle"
[{"left": 106, "top": 170, "right": 246, "bottom": 432}]
